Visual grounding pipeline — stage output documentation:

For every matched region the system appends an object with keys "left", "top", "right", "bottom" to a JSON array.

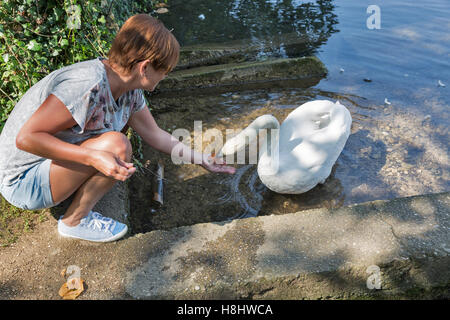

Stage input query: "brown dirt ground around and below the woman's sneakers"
[{"left": 0, "top": 213, "right": 135, "bottom": 300}]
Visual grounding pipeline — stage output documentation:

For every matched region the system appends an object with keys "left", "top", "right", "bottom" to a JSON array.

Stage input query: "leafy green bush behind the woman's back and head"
[{"left": 0, "top": 0, "right": 159, "bottom": 132}]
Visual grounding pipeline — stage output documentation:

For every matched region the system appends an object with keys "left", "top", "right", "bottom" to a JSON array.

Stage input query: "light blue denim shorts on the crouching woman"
[{"left": 0, "top": 159, "right": 57, "bottom": 210}]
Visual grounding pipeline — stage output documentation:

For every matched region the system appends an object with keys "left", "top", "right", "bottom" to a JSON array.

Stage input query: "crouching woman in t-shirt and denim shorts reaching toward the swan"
[{"left": 0, "top": 14, "right": 234, "bottom": 242}]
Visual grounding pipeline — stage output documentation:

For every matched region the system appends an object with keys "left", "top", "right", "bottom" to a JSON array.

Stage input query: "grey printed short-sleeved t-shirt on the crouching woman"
[{"left": 0, "top": 58, "right": 146, "bottom": 185}]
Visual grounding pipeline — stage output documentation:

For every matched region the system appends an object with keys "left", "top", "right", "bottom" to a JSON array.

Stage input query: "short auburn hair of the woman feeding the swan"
[{"left": 108, "top": 14, "right": 180, "bottom": 74}]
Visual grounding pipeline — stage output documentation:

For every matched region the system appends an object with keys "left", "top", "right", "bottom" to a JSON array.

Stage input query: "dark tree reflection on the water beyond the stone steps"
[{"left": 158, "top": 0, "right": 338, "bottom": 57}]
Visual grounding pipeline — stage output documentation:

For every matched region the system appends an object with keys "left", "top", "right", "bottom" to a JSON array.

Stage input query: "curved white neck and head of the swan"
[{"left": 218, "top": 115, "right": 280, "bottom": 169}]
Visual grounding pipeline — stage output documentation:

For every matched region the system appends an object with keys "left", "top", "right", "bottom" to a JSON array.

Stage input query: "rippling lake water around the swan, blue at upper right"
[{"left": 131, "top": 0, "right": 450, "bottom": 231}]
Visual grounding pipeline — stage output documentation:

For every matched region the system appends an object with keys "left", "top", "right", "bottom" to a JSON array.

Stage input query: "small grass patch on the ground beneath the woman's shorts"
[{"left": 0, "top": 196, "right": 47, "bottom": 247}]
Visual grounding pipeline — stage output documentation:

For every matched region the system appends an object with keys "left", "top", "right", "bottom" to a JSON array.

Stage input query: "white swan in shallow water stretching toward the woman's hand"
[{"left": 218, "top": 100, "right": 352, "bottom": 194}]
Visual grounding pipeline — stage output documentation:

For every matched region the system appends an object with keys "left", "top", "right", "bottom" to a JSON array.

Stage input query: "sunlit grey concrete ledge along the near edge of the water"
[{"left": 121, "top": 193, "right": 450, "bottom": 299}]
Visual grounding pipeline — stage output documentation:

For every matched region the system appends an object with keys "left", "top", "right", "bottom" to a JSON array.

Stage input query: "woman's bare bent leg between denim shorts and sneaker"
[{"left": 50, "top": 131, "right": 132, "bottom": 226}]
